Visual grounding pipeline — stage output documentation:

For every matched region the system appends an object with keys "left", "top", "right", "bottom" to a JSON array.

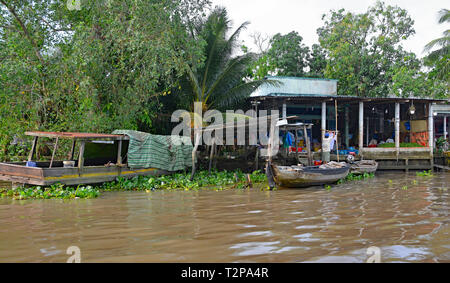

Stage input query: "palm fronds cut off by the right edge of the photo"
[{"left": 424, "top": 9, "right": 450, "bottom": 78}]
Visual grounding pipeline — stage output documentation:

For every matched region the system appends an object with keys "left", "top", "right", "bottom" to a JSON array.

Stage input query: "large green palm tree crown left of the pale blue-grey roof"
[{"left": 180, "top": 7, "right": 272, "bottom": 110}]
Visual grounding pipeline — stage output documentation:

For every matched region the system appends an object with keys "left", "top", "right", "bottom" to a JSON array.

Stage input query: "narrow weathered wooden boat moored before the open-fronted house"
[{"left": 268, "top": 163, "right": 350, "bottom": 188}]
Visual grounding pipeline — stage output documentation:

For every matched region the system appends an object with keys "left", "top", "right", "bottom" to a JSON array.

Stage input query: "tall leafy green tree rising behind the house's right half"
[{"left": 317, "top": 1, "right": 415, "bottom": 96}]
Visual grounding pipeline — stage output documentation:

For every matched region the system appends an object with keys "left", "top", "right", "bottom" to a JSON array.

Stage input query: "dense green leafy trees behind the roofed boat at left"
[{"left": 0, "top": 0, "right": 209, "bottom": 159}]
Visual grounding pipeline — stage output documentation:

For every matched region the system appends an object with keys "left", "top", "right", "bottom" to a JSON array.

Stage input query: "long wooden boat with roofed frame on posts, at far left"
[{"left": 0, "top": 132, "right": 168, "bottom": 186}]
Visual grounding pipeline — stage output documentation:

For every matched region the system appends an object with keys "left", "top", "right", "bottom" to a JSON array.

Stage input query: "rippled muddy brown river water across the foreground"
[{"left": 0, "top": 173, "right": 450, "bottom": 262}]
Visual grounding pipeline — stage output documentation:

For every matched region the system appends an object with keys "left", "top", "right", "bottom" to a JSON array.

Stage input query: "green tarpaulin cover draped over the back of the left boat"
[{"left": 113, "top": 130, "right": 193, "bottom": 171}]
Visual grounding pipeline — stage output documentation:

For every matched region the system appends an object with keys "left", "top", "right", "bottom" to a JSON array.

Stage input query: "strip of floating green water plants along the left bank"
[{"left": 0, "top": 170, "right": 266, "bottom": 199}]
